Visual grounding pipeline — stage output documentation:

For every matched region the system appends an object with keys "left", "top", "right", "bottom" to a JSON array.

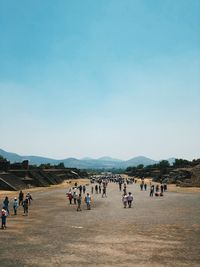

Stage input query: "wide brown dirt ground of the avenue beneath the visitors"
[{"left": 0, "top": 181, "right": 200, "bottom": 267}]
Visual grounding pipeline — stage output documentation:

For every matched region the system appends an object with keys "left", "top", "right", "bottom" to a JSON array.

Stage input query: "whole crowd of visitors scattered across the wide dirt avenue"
[{"left": 1, "top": 175, "right": 167, "bottom": 229}]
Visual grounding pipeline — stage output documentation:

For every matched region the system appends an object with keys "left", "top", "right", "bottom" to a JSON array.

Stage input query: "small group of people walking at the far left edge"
[{"left": 1, "top": 191, "right": 33, "bottom": 229}]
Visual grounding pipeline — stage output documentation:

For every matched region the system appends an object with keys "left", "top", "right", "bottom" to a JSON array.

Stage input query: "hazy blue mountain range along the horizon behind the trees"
[{"left": 0, "top": 149, "right": 175, "bottom": 169}]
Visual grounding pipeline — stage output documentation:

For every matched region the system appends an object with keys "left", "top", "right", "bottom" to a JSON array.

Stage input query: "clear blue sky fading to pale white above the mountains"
[{"left": 0, "top": 0, "right": 200, "bottom": 159}]
